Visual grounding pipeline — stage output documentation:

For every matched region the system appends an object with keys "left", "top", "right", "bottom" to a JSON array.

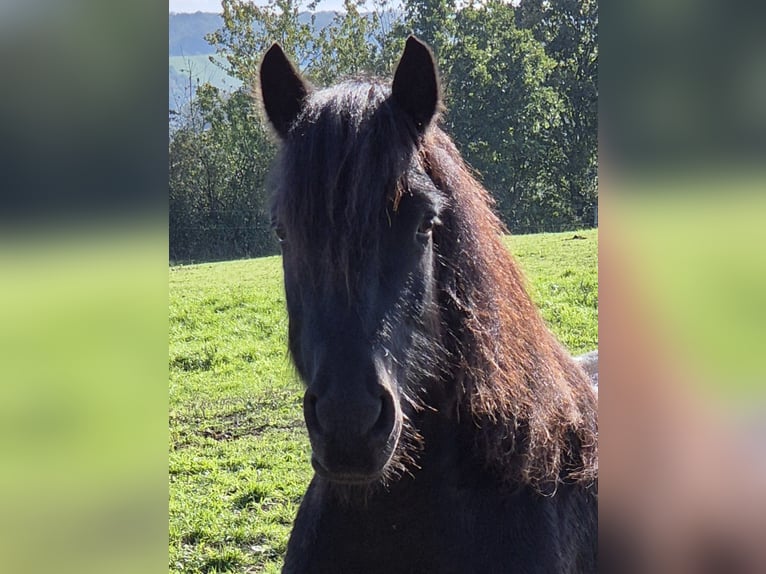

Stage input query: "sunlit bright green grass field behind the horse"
[{"left": 169, "top": 230, "right": 598, "bottom": 573}]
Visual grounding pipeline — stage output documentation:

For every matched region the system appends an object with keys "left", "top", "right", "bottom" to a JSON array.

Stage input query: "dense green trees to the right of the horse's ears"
[{"left": 402, "top": 0, "right": 598, "bottom": 232}]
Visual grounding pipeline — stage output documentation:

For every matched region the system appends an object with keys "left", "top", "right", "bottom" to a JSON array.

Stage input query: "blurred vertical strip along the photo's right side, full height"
[{"left": 599, "top": 0, "right": 766, "bottom": 574}]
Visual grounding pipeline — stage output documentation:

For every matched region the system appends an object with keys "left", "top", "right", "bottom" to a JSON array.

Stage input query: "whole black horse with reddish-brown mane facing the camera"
[{"left": 260, "top": 37, "right": 598, "bottom": 574}]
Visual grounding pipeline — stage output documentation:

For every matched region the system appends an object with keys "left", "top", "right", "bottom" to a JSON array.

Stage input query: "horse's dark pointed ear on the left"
[{"left": 261, "top": 43, "right": 309, "bottom": 138}]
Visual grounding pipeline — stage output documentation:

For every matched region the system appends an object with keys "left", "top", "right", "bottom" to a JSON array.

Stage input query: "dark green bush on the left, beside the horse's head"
[{"left": 169, "top": 84, "right": 276, "bottom": 261}]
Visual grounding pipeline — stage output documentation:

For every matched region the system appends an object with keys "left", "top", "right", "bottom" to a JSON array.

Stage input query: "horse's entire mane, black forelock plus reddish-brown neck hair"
[{"left": 272, "top": 79, "right": 598, "bottom": 491}]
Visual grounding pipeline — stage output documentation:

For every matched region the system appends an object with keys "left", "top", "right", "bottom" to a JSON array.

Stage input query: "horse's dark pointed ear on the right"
[{"left": 391, "top": 36, "right": 440, "bottom": 133}]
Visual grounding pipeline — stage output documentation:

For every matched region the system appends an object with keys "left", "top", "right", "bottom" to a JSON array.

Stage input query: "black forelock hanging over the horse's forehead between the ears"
[{"left": 272, "top": 80, "right": 424, "bottom": 296}]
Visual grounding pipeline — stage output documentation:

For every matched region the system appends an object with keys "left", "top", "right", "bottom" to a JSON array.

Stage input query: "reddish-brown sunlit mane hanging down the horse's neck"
[{"left": 420, "top": 127, "right": 598, "bottom": 491}]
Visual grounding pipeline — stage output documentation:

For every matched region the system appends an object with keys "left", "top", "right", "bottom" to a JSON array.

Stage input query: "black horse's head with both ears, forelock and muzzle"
[{"left": 260, "top": 37, "right": 446, "bottom": 484}]
